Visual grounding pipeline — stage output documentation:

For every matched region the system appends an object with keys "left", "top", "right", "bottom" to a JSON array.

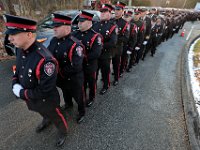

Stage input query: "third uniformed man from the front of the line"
[{"left": 73, "top": 10, "right": 103, "bottom": 107}]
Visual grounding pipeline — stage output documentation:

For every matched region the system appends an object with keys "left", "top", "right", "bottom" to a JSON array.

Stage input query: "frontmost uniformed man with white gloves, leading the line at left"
[{"left": 5, "top": 15, "right": 68, "bottom": 146}]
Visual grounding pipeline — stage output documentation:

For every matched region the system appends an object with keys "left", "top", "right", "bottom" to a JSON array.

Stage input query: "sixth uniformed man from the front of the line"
[{"left": 120, "top": 11, "right": 137, "bottom": 76}]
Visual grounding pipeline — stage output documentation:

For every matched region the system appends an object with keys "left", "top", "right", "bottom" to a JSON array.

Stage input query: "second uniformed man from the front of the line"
[{"left": 48, "top": 13, "right": 85, "bottom": 123}]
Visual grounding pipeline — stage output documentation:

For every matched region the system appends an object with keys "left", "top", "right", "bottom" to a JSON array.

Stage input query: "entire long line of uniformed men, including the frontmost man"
[{"left": 5, "top": 2, "right": 200, "bottom": 146}]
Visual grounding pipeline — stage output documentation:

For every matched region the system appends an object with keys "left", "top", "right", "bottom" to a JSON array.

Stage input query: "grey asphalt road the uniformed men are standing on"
[{"left": 0, "top": 23, "right": 197, "bottom": 150}]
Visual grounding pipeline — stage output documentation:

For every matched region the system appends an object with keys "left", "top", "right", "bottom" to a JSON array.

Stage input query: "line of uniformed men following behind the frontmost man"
[{"left": 45, "top": 2, "right": 197, "bottom": 138}]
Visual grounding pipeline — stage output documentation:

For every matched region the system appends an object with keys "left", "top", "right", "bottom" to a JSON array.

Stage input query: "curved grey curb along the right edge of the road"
[{"left": 180, "top": 35, "right": 200, "bottom": 150}]
